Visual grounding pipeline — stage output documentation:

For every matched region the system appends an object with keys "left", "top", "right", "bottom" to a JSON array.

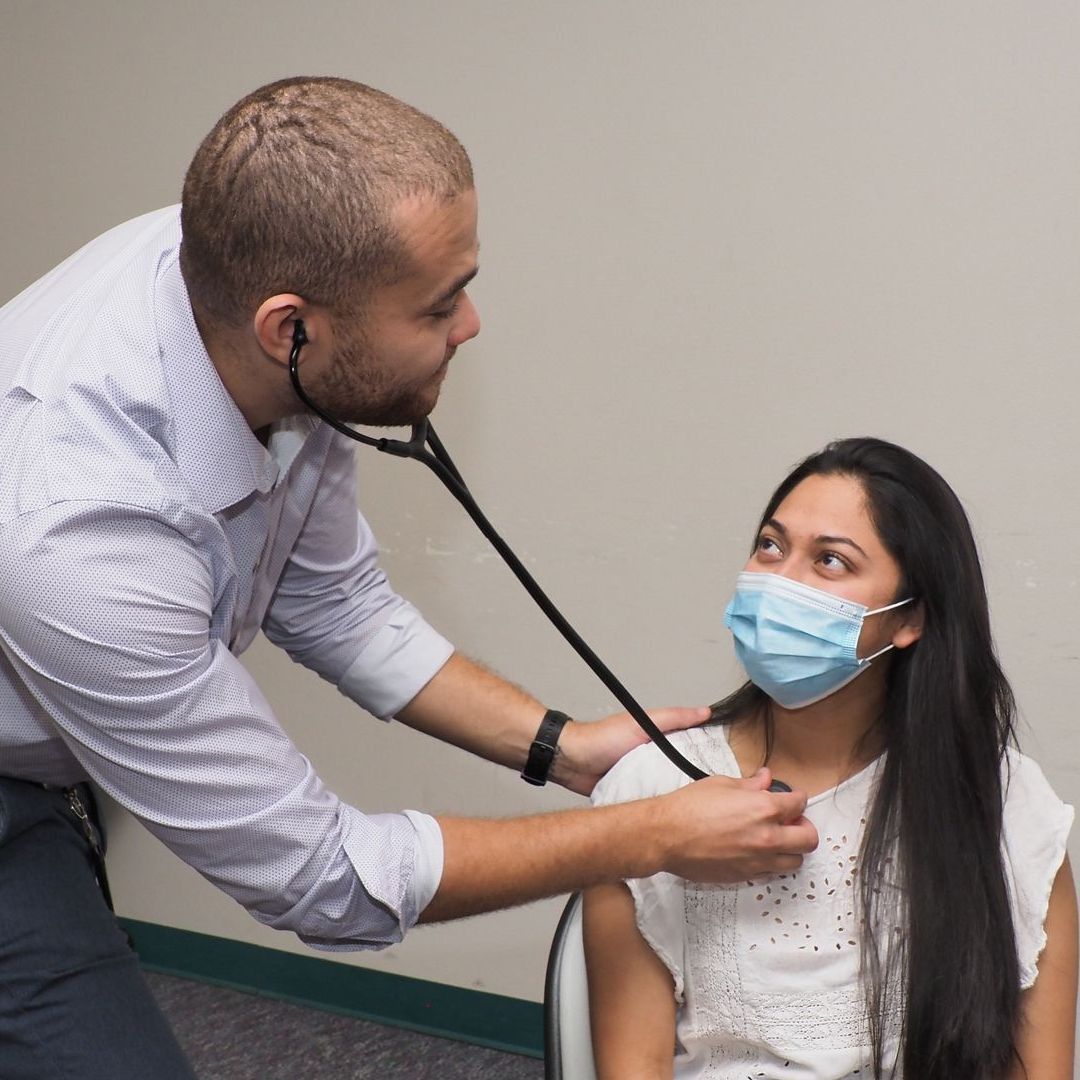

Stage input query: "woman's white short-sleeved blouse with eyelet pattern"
[{"left": 593, "top": 725, "right": 1072, "bottom": 1080}]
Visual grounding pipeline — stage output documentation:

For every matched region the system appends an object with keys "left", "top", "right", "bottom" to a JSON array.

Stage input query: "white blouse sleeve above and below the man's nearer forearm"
[{"left": 592, "top": 737, "right": 690, "bottom": 1004}]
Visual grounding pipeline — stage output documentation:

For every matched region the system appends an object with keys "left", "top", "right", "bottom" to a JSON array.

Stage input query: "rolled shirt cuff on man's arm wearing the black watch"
[{"left": 338, "top": 602, "right": 454, "bottom": 720}]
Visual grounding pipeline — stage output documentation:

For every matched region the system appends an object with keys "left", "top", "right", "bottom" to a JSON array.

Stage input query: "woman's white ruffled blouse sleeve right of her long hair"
[{"left": 1002, "top": 752, "right": 1074, "bottom": 990}]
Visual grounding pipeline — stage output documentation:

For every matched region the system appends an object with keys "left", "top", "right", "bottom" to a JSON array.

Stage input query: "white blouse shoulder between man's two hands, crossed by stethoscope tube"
[{"left": 593, "top": 724, "right": 739, "bottom": 806}]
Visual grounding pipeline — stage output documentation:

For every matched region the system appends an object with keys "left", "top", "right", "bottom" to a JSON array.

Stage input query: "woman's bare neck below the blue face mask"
[{"left": 728, "top": 665, "right": 886, "bottom": 795}]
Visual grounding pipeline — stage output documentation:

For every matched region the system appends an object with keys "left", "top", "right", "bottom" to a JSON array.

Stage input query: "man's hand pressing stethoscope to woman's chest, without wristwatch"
[{"left": 654, "top": 769, "right": 818, "bottom": 882}]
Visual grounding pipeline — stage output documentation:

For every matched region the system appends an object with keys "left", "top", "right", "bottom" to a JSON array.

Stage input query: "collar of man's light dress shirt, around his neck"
[{"left": 154, "top": 249, "right": 314, "bottom": 513}]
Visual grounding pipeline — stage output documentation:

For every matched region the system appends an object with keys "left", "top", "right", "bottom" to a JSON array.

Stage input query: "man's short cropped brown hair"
[{"left": 180, "top": 77, "right": 473, "bottom": 326}]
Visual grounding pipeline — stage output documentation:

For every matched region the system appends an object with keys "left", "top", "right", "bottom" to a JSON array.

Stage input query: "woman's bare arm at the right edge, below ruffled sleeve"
[{"left": 1010, "top": 855, "right": 1077, "bottom": 1080}]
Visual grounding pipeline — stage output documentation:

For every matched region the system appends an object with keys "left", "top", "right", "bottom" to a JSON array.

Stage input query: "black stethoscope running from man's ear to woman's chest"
[{"left": 288, "top": 319, "right": 791, "bottom": 791}]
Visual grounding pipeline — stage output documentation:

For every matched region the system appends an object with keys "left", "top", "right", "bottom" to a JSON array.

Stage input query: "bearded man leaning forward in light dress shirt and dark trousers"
[{"left": 0, "top": 79, "right": 816, "bottom": 1080}]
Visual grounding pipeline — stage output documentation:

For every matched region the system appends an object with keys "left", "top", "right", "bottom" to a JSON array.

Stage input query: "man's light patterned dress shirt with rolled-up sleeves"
[{"left": 0, "top": 207, "right": 453, "bottom": 948}]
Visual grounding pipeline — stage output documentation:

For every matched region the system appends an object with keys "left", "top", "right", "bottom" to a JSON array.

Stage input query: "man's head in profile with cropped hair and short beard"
[{"left": 180, "top": 78, "right": 480, "bottom": 427}]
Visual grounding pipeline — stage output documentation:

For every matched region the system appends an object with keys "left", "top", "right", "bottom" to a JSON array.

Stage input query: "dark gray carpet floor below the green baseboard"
[{"left": 146, "top": 972, "right": 543, "bottom": 1080}]
